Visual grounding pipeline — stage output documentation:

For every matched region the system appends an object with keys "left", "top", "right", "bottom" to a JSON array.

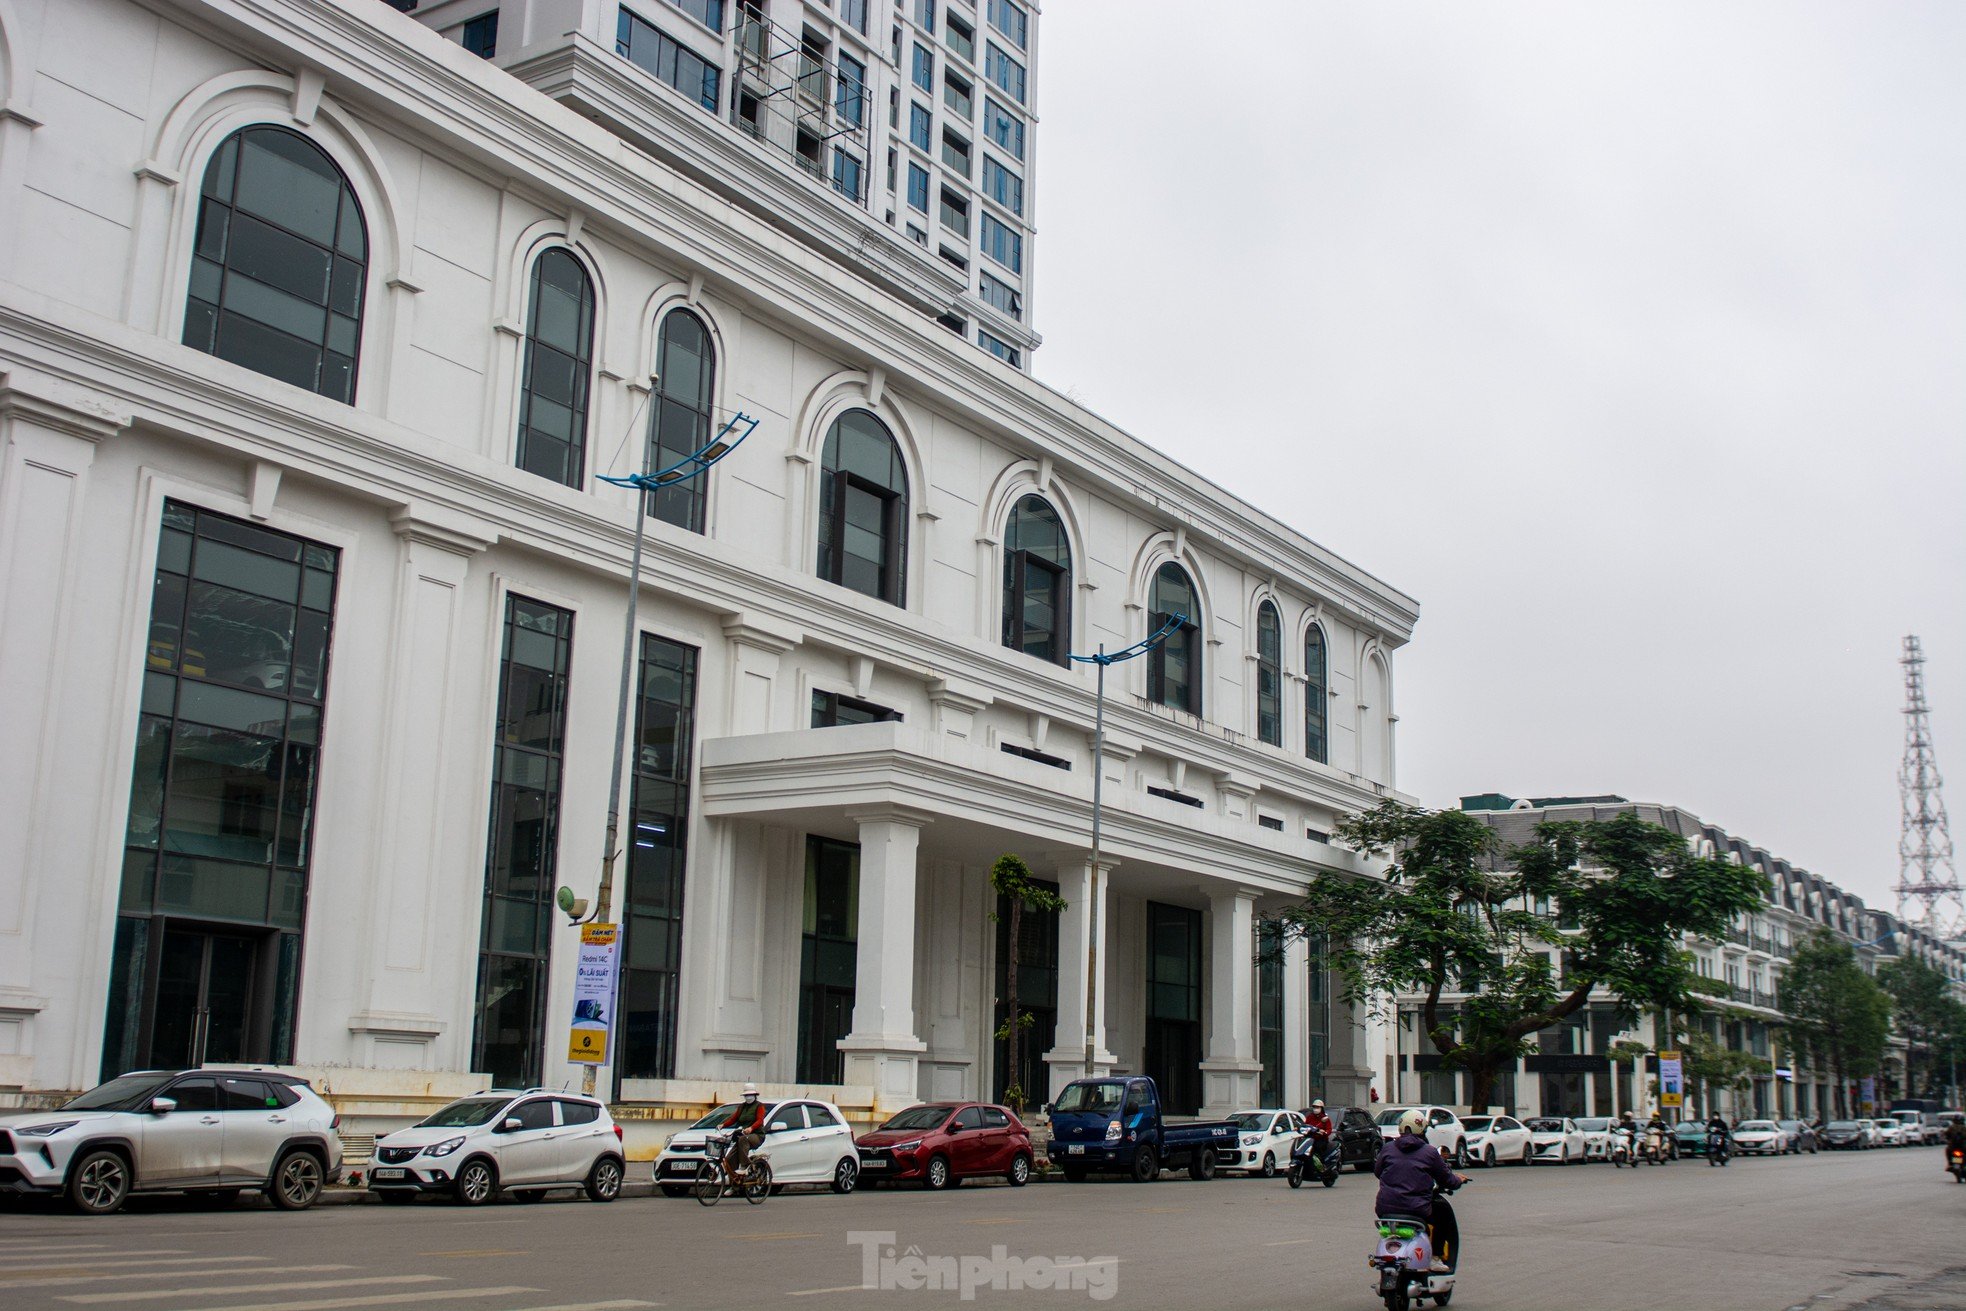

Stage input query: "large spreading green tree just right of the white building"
[{"left": 1282, "top": 802, "right": 1760, "bottom": 1111}]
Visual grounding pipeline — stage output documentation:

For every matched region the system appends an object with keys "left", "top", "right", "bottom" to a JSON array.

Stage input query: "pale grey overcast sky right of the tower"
[{"left": 1034, "top": 0, "right": 1966, "bottom": 906}]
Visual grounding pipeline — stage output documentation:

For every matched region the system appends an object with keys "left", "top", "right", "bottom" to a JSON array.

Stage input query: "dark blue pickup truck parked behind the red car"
[{"left": 1046, "top": 1075, "right": 1237, "bottom": 1183}]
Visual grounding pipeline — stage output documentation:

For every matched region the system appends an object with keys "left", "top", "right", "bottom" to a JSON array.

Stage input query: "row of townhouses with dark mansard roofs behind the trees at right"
[{"left": 1372, "top": 792, "right": 1966, "bottom": 1118}]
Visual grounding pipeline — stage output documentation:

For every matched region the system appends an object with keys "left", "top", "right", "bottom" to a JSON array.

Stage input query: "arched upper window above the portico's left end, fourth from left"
[{"left": 820, "top": 409, "right": 908, "bottom": 605}]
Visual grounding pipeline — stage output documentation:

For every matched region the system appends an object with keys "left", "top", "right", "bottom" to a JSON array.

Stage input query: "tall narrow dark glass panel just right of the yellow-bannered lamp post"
[{"left": 615, "top": 633, "right": 696, "bottom": 1079}]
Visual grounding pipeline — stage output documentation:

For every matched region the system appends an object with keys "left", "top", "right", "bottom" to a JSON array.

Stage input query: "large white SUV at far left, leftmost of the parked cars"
[{"left": 0, "top": 1069, "right": 342, "bottom": 1215}]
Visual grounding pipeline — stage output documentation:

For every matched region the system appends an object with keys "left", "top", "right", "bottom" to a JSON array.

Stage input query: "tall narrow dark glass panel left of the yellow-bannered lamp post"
[{"left": 472, "top": 596, "right": 574, "bottom": 1087}]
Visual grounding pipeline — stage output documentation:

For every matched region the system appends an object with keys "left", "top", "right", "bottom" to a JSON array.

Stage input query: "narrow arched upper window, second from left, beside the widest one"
[{"left": 519, "top": 246, "right": 594, "bottom": 487}]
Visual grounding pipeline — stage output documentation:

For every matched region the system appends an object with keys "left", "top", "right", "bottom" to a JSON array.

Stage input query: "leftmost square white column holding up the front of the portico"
[{"left": 839, "top": 808, "right": 928, "bottom": 1114}]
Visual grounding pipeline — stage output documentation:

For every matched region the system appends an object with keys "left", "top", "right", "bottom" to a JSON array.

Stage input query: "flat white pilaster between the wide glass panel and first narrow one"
[{"left": 348, "top": 505, "right": 497, "bottom": 1069}]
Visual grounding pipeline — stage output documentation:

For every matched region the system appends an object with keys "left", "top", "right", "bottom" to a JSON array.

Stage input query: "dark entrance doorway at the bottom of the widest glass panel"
[{"left": 145, "top": 928, "right": 260, "bottom": 1067}]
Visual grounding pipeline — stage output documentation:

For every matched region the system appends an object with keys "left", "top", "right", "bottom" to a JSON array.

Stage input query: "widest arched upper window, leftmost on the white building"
[{"left": 185, "top": 126, "right": 368, "bottom": 401}]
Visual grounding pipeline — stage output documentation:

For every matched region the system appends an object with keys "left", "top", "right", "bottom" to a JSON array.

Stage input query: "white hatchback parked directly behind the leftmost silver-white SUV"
[{"left": 368, "top": 1089, "right": 623, "bottom": 1207}]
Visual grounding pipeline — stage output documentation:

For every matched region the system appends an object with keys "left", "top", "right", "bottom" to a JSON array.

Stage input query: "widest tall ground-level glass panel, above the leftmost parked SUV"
[{"left": 102, "top": 501, "right": 340, "bottom": 1077}]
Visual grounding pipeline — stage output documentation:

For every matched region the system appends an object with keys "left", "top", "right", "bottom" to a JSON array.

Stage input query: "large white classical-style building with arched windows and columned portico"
[{"left": 0, "top": 0, "right": 1416, "bottom": 1120}]
